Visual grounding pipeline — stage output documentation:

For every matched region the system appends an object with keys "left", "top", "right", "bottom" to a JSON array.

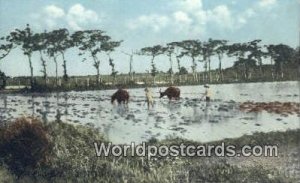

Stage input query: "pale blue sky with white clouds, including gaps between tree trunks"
[{"left": 0, "top": 0, "right": 300, "bottom": 76}]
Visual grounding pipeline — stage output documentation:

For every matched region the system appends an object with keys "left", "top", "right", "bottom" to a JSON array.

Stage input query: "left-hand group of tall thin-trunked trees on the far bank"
[{"left": 0, "top": 24, "right": 122, "bottom": 86}]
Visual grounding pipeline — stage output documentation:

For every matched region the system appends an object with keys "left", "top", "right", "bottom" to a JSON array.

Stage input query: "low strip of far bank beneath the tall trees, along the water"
[{"left": 0, "top": 65, "right": 299, "bottom": 93}]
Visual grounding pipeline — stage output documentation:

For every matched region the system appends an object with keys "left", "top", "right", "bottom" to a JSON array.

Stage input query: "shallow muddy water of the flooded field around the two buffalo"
[{"left": 0, "top": 82, "right": 300, "bottom": 143}]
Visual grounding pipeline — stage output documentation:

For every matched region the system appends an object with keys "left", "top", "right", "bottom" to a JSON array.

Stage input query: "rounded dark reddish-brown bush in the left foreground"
[{"left": 0, "top": 118, "right": 51, "bottom": 175}]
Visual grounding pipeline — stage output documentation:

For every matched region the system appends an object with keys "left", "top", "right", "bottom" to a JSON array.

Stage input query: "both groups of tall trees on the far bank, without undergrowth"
[{"left": 0, "top": 25, "right": 299, "bottom": 86}]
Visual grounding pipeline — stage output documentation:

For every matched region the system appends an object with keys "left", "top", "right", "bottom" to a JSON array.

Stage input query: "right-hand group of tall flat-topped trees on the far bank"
[{"left": 140, "top": 38, "right": 299, "bottom": 82}]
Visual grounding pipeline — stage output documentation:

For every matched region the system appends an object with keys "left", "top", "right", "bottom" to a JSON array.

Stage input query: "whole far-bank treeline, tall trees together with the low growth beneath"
[{"left": 0, "top": 25, "right": 300, "bottom": 89}]
